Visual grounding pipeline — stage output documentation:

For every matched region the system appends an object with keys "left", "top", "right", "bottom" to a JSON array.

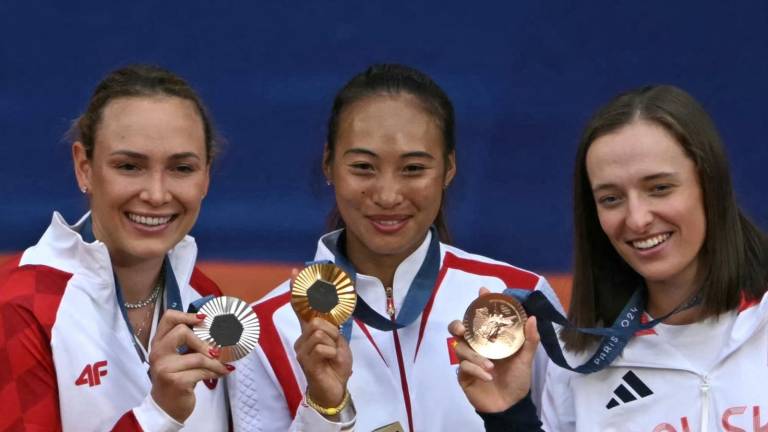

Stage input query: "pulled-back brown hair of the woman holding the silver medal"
[{"left": 68, "top": 65, "right": 219, "bottom": 164}]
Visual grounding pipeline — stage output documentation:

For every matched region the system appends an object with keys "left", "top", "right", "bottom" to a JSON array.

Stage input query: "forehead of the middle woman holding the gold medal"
[{"left": 337, "top": 94, "right": 443, "bottom": 152}]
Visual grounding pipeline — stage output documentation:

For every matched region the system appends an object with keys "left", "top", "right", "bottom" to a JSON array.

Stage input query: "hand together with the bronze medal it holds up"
[{"left": 448, "top": 288, "right": 539, "bottom": 412}]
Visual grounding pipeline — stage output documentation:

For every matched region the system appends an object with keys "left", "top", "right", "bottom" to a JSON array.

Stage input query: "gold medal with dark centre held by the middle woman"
[{"left": 291, "top": 263, "right": 357, "bottom": 326}]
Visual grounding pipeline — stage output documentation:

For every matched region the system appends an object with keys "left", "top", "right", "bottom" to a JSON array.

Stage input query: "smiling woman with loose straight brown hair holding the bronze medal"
[{"left": 451, "top": 86, "right": 768, "bottom": 432}]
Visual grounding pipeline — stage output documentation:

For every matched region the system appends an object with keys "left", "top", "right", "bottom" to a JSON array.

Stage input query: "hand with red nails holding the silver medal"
[{"left": 149, "top": 309, "right": 234, "bottom": 423}]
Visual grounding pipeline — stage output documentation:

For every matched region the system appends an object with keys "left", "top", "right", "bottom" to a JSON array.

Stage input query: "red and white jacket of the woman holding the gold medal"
[{"left": 229, "top": 234, "right": 559, "bottom": 431}]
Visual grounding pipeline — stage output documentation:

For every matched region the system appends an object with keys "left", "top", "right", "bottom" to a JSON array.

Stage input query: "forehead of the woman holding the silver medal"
[{"left": 95, "top": 96, "right": 205, "bottom": 152}]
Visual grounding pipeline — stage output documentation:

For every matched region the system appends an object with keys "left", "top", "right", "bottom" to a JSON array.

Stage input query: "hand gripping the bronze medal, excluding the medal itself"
[{"left": 448, "top": 289, "right": 539, "bottom": 413}]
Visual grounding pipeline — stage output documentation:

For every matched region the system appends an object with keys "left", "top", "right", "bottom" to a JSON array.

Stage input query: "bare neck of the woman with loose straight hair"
[{"left": 646, "top": 278, "right": 702, "bottom": 325}]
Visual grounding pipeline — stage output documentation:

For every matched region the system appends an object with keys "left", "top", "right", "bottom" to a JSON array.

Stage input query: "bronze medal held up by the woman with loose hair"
[{"left": 464, "top": 294, "right": 527, "bottom": 359}]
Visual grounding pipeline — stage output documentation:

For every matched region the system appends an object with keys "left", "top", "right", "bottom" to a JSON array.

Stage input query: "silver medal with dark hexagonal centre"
[{"left": 192, "top": 296, "right": 259, "bottom": 363}]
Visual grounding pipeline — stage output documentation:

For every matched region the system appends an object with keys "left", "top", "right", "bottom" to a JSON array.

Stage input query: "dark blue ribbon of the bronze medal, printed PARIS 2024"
[{"left": 504, "top": 288, "right": 700, "bottom": 374}]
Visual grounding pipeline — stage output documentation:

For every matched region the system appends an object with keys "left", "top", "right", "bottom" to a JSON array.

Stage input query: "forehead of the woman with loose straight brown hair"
[{"left": 586, "top": 120, "right": 695, "bottom": 185}]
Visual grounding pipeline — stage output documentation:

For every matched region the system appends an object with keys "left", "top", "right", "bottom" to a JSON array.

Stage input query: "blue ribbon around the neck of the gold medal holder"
[{"left": 316, "top": 227, "right": 440, "bottom": 340}]
